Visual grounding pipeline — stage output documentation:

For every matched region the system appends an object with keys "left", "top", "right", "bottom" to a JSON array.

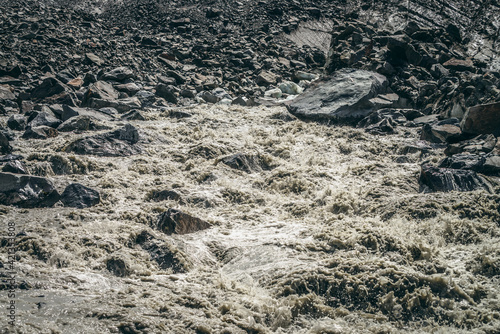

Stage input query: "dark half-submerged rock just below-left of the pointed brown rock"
[{"left": 135, "top": 231, "right": 186, "bottom": 273}]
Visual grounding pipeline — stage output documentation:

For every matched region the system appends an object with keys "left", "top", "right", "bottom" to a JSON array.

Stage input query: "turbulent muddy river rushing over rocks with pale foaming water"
[{"left": 0, "top": 105, "right": 500, "bottom": 334}]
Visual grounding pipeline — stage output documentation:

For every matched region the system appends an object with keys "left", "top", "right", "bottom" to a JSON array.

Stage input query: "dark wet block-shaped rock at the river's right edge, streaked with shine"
[{"left": 420, "top": 165, "right": 491, "bottom": 192}]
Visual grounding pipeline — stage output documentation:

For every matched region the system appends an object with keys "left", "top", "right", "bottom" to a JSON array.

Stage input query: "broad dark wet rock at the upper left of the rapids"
[{"left": 64, "top": 124, "right": 142, "bottom": 157}]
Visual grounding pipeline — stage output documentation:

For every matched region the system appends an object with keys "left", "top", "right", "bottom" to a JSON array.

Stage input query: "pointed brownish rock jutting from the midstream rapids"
[{"left": 156, "top": 209, "right": 211, "bottom": 235}]
